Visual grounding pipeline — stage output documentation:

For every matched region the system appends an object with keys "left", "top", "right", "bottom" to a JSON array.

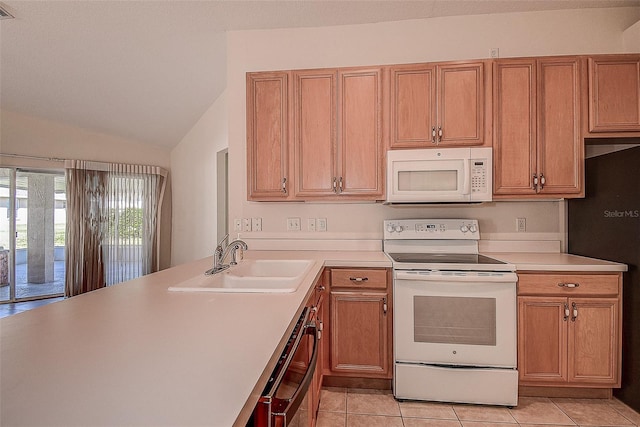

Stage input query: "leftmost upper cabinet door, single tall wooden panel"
[{"left": 247, "top": 72, "right": 290, "bottom": 200}]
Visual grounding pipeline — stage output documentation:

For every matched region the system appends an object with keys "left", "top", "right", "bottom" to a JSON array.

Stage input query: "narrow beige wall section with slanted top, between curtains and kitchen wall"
[{"left": 171, "top": 92, "right": 229, "bottom": 265}]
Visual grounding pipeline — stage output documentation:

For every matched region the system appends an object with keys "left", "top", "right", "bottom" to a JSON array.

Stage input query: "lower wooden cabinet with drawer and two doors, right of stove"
[{"left": 518, "top": 273, "right": 622, "bottom": 388}]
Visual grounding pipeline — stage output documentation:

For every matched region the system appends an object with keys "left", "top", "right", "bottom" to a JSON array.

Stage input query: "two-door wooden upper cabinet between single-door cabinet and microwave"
[{"left": 293, "top": 68, "right": 384, "bottom": 200}]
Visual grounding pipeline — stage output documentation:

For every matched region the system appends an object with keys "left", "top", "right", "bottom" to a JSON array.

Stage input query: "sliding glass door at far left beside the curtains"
[{"left": 0, "top": 168, "right": 66, "bottom": 301}]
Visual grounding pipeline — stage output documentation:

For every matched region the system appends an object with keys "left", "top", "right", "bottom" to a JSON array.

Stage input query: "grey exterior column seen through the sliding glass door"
[{"left": 27, "top": 174, "right": 55, "bottom": 283}]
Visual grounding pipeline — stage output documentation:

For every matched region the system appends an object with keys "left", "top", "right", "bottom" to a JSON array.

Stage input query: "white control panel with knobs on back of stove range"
[{"left": 384, "top": 219, "right": 480, "bottom": 240}]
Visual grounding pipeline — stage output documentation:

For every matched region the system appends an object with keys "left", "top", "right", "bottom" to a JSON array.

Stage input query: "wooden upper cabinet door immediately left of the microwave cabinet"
[{"left": 336, "top": 68, "right": 383, "bottom": 199}]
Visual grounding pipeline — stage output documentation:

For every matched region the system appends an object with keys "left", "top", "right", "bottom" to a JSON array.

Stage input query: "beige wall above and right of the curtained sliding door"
[{"left": 0, "top": 110, "right": 171, "bottom": 268}]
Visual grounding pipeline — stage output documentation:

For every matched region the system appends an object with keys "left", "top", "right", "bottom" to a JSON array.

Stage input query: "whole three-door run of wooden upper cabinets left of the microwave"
[{"left": 247, "top": 68, "right": 384, "bottom": 201}]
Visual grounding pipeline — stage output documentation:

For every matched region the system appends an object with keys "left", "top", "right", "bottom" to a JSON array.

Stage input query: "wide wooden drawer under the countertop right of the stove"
[{"left": 518, "top": 273, "right": 620, "bottom": 296}]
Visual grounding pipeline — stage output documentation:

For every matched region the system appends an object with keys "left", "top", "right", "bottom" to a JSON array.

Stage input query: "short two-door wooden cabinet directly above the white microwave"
[{"left": 389, "top": 61, "right": 491, "bottom": 149}]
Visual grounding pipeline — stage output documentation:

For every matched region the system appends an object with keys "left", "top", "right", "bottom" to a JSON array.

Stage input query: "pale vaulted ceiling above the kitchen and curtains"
[{"left": 0, "top": 0, "right": 640, "bottom": 148}]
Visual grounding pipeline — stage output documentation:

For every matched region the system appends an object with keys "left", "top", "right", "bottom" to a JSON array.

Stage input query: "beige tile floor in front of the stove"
[{"left": 316, "top": 388, "right": 640, "bottom": 427}]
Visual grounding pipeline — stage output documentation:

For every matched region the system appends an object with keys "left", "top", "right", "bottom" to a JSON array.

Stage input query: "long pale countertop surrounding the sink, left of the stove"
[{"left": 0, "top": 251, "right": 391, "bottom": 427}]
